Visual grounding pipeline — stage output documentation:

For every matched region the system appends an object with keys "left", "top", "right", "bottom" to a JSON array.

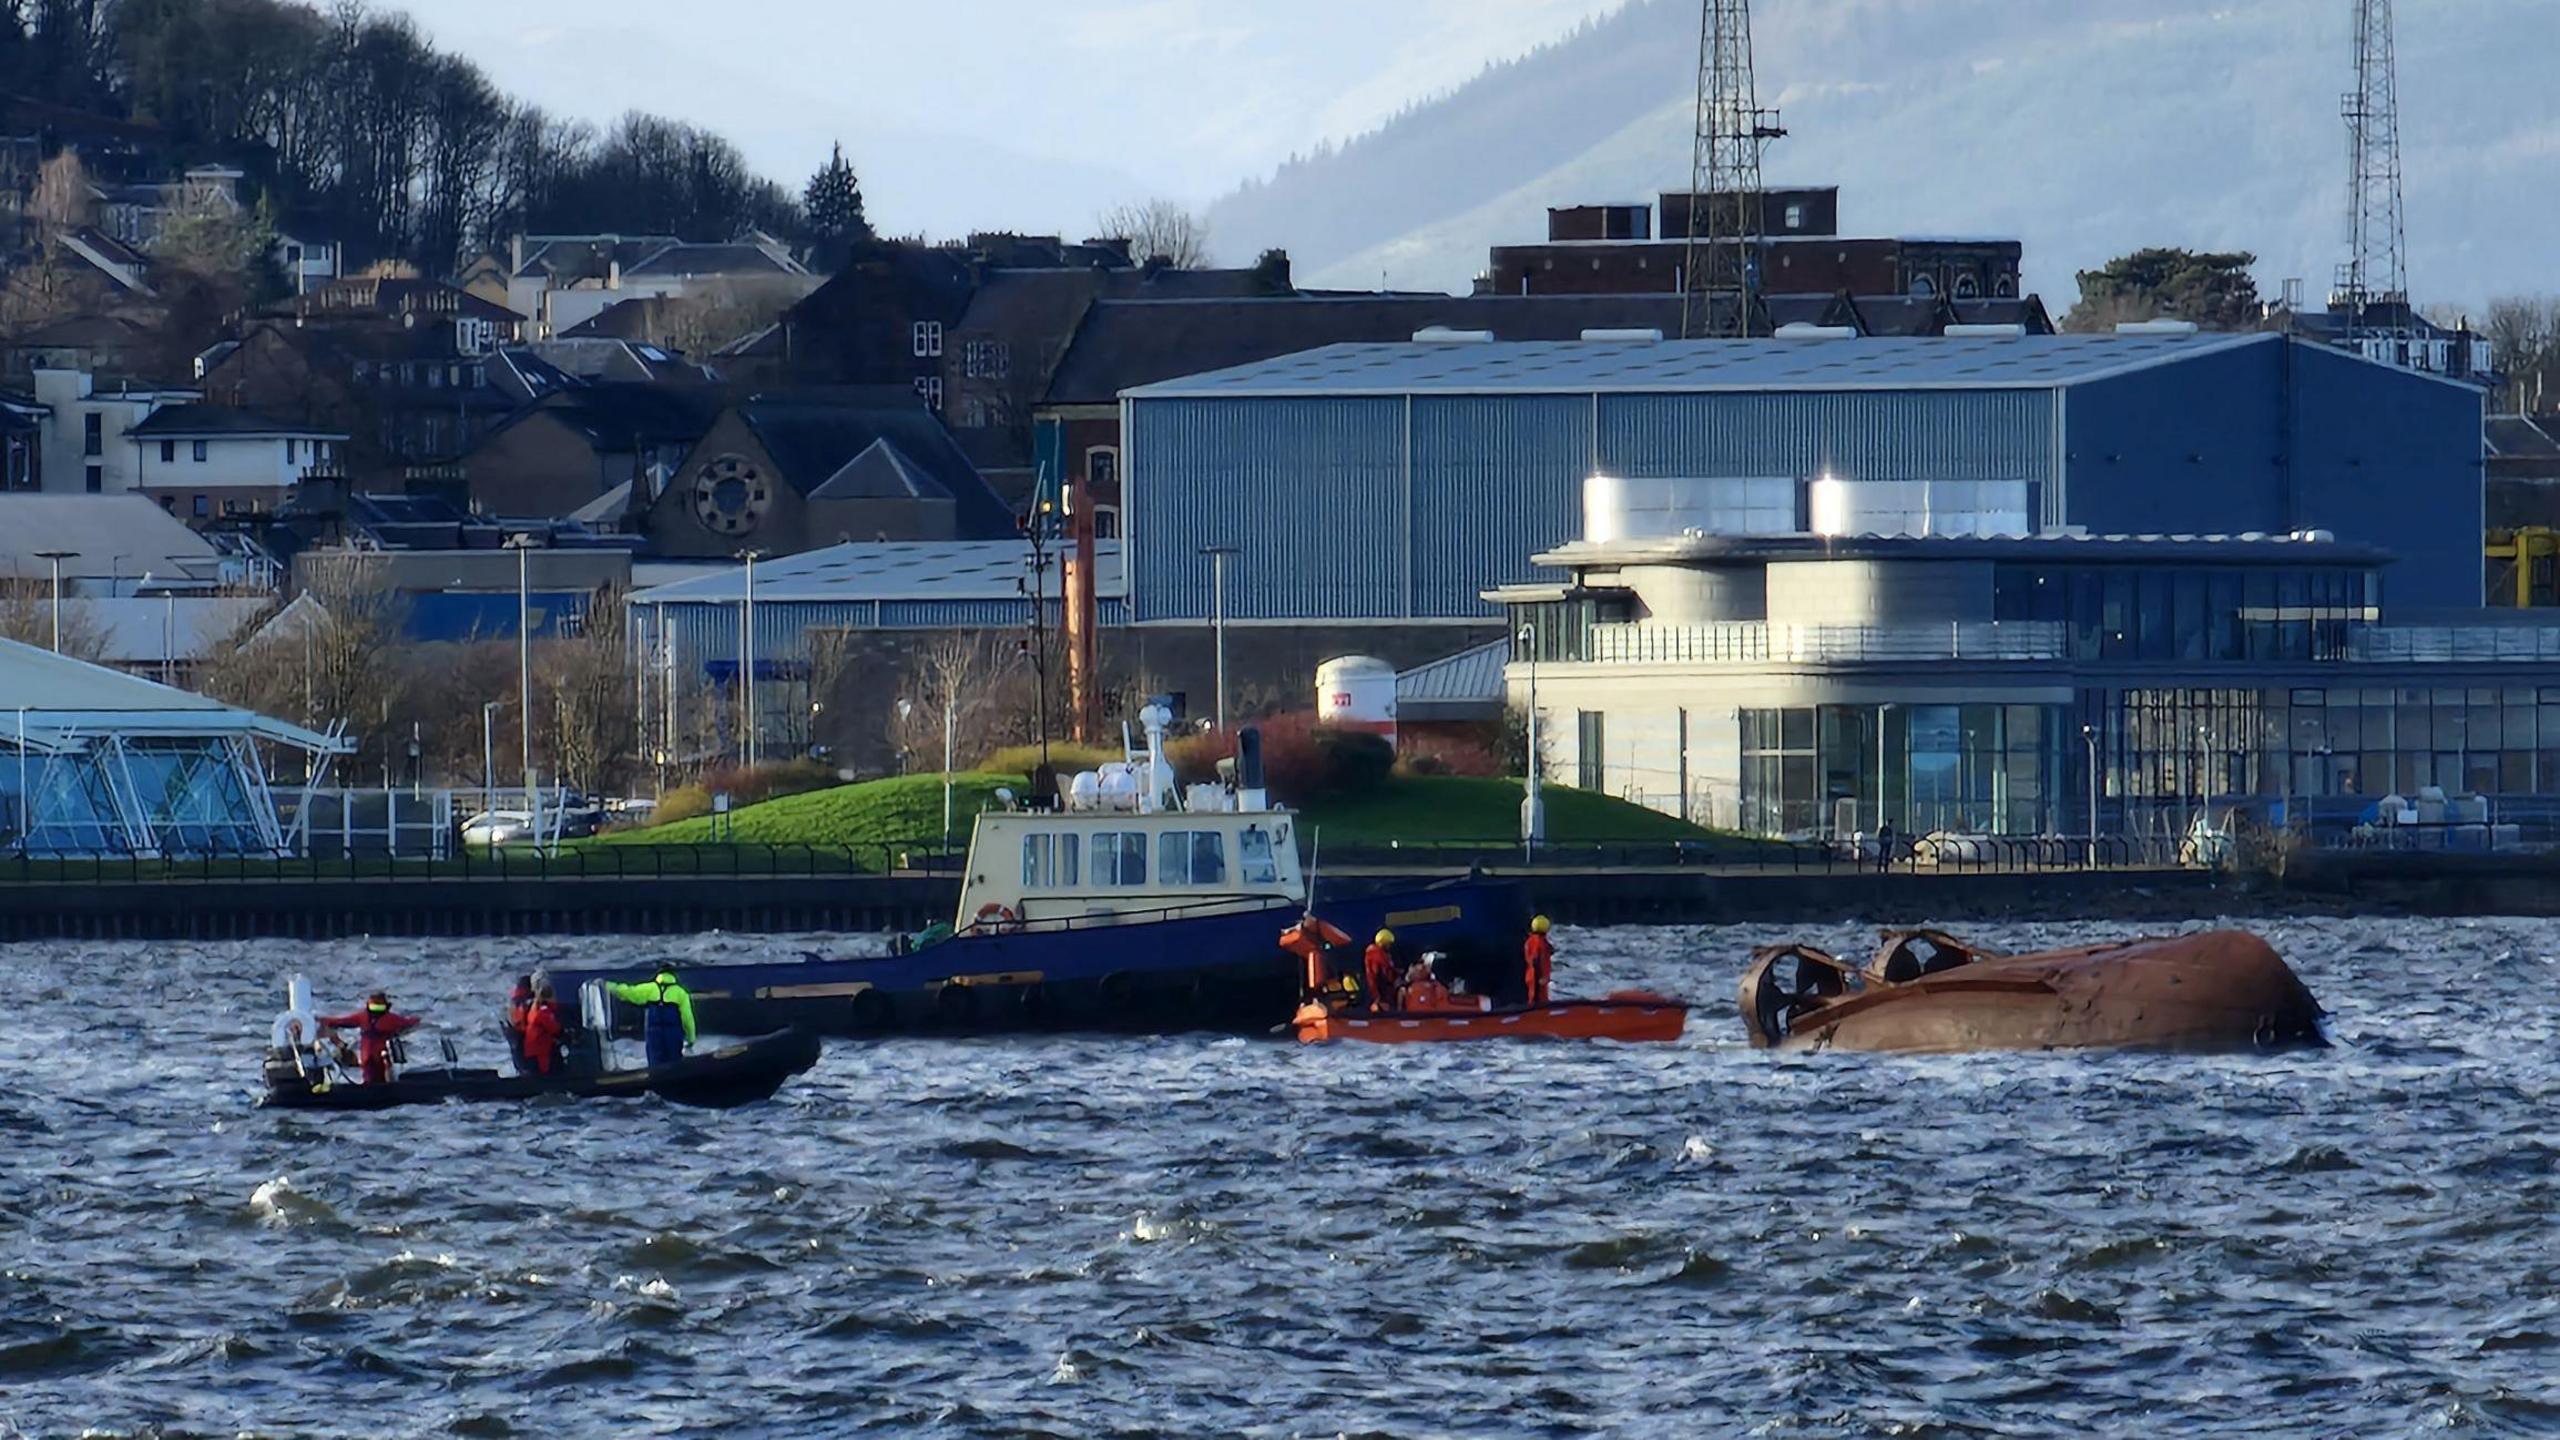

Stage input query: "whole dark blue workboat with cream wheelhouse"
[{"left": 553, "top": 705, "right": 1528, "bottom": 1035}]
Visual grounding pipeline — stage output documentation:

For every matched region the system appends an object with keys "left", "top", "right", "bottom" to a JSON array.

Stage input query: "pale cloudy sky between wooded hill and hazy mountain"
[{"left": 409, "top": 0, "right": 1620, "bottom": 236}]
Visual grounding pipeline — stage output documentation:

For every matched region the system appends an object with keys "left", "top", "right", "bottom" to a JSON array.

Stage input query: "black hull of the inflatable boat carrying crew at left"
[{"left": 261, "top": 1030, "right": 819, "bottom": 1109}]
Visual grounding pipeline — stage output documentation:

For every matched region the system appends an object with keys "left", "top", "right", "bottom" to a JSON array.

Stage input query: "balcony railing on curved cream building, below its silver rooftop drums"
[{"left": 1585, "top": 620, "right": 2071, "bottom": 666}]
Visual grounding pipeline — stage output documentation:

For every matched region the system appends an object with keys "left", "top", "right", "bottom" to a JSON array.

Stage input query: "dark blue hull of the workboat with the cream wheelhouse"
[{"left": 550, "top": 879, "right": 1528, "bottom": 1038}]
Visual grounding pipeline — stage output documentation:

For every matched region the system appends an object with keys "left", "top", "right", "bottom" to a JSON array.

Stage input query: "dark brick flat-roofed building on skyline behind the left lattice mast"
[{"left": 1477, "top": 187, "right": 2022, "bottom": 300}]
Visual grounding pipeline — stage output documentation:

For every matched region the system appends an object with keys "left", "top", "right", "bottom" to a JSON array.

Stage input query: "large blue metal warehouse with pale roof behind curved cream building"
[{"left": 1124, "top": 333, "right": 2481, "bottom": 625}]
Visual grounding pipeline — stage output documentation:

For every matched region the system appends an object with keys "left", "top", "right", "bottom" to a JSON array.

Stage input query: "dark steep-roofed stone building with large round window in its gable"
[{"left": 632, "top": 387, "right": 1016, "bottom": 556}]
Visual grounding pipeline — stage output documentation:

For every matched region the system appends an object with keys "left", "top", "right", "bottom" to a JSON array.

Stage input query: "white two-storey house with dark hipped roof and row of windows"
[{"left": 125, "top": 402, "right": 346, "bottom": 523}]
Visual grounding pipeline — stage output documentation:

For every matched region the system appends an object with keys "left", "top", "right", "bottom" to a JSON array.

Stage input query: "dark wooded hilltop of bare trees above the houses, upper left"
[{"left": 0, "top": 0, "right": 798, "bottom": 274}]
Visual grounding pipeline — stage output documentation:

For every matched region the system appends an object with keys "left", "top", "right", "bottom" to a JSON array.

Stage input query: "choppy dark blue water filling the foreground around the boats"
[{"left": 0, "top": 920, "right": 2560, "bottom": 1437}]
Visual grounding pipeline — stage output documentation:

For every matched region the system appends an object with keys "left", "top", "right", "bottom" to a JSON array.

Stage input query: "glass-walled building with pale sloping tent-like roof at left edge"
[{"left": 0, "top": 630, "right": 351, "bottom": 858}]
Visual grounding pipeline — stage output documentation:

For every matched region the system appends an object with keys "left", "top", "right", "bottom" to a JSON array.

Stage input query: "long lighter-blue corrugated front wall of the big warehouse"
[{"left": 1126, "top": 389, "right": 2053, "bottom": 623}]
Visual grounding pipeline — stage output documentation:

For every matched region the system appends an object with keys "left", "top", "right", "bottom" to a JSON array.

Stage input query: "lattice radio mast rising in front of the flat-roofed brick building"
[{"left": 1679, "top": 0, "right": 1787, "bottom": 338}]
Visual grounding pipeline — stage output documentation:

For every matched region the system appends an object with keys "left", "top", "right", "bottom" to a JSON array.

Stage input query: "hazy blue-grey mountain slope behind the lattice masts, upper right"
[{"left": 1208, "top": 0, "right": 2560, "bottom": 305}]
